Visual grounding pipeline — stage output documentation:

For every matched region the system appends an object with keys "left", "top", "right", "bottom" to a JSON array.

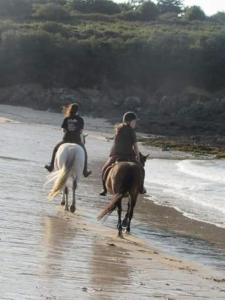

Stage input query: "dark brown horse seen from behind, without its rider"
[{"left": 97, "top": 153, "right": 148, "bottom": 237}]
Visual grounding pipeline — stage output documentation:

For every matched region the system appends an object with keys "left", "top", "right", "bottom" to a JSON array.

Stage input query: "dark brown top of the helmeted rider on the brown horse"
[{"left": 110, "top": 125, "right": 137, "bottom": 159}]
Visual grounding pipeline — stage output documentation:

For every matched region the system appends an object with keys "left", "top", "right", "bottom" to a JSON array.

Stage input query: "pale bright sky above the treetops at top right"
[{"left": 184, "top": 0, "right": 225, "bottom": 16}]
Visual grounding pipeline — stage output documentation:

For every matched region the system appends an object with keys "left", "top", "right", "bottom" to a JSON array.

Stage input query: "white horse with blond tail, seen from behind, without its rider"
[{"left": 48, "top": 143, "right": 85, "bottom": 212}]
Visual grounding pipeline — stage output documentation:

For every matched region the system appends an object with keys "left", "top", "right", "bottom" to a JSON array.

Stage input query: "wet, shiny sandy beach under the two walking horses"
[{"left": 0, "top": 105, "right": 225, "bottom": 300}]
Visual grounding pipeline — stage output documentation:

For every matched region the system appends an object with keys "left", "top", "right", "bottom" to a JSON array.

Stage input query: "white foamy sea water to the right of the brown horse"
[{"left": 146, "top": 159, "right": 225, "bottom": 227}]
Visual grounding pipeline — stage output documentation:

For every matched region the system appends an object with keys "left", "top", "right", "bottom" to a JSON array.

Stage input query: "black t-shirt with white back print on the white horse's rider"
[{"left": 62, "top": 115, "right": 84, "bottom": 143}]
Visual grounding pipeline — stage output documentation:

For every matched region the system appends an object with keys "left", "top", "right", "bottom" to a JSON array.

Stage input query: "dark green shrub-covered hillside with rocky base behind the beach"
[{"left": 0, "top": 0, "right": 225, "bottom": 139}]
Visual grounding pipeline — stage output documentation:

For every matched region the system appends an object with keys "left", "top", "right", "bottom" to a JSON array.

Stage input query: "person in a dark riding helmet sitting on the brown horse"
[{"left": 100, "top": 112, "right": 145, "bottom": 196}]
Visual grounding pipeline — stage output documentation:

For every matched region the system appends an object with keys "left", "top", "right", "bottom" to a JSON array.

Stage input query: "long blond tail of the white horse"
[{"left": 48, "top": 155, "right": 75, "bottom": 200}]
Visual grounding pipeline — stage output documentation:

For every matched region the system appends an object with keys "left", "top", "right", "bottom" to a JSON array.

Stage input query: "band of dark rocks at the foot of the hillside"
[{"left": 0, "top": 84, "right": 225, "bottom": 136}]
